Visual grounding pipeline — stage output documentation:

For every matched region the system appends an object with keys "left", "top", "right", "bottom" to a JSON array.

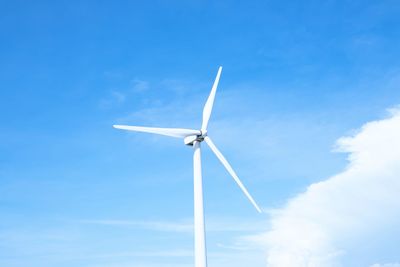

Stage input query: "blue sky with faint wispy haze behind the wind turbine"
[{"left": 0, "top": 1, "right": 400, "bottom": 267}]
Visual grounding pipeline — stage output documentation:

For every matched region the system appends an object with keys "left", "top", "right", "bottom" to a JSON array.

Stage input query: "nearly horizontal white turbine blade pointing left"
[{"left": 113, "top": 125, "right": 201, "bottom": 138}]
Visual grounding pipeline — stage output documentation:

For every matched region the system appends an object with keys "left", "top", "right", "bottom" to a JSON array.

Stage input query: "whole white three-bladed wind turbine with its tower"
[{"left": 113, "top": 67, "right": 261, "bottom": 267}]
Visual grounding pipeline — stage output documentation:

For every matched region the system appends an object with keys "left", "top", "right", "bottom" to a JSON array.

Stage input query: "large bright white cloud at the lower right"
[{"left": 253, "top": 108, "right": 400, "bottom": 267}]
